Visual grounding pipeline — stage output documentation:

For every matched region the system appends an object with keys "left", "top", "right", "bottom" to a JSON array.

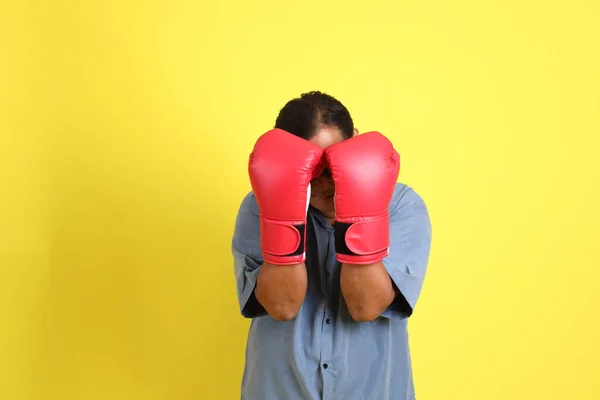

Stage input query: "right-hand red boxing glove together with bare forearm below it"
[{"left": 325, "top": 132, "right": 400, "bottom": 321}]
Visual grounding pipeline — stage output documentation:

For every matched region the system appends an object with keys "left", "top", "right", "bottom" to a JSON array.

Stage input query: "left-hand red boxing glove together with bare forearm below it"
[{"left": 243, "top": 129, "right": 323, "bottom": 321}]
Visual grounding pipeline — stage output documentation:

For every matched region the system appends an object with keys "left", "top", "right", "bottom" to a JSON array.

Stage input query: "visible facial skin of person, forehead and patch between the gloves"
[{"left": 310, "top": 126, "right": 352, "bottom": 220}]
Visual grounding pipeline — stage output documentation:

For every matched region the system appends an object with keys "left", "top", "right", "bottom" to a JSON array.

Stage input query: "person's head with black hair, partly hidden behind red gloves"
[{"left": 275, "top": 92, "right": 357, "bottom": 218}]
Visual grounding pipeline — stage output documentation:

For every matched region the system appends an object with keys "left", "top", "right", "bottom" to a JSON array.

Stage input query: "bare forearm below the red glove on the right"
[{"left": 340, "top": 261, "right": 396, "bottom": 322}]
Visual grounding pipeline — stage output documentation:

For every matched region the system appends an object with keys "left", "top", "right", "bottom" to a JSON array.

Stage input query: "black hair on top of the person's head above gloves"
[{"left": 275, "top": 91, "right": 354, "bottom": 140}]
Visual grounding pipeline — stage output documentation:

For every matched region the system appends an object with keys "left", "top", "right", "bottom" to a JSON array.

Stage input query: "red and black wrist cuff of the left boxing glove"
[{"left": 260, "top": 217, "right": 306, "bottom": 265}]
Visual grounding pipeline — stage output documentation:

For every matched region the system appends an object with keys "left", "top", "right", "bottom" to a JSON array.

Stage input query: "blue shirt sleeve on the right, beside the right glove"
[{"left": 381, "top": 188, "right": 431, "bottom": 318}]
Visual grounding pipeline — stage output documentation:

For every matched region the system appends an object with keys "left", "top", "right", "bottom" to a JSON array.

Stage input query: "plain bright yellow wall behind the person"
[{"left": 0, "top": 0, "right": 600, "bottom": 400}]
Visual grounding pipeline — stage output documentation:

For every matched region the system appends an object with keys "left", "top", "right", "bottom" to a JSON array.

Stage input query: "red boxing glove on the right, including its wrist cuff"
[{"left": 325, "top": 132, "right": 400, "bottom": 264}]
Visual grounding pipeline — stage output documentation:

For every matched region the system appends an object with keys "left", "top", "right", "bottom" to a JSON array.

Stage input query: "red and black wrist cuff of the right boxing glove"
[{"left": 335, "top": 214, "right": 390, "bottom": 264}]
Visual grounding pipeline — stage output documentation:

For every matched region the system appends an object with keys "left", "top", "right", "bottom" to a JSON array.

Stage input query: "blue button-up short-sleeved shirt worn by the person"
[{"left": 232, "top": 183, "right": 431, "bottom": 400}]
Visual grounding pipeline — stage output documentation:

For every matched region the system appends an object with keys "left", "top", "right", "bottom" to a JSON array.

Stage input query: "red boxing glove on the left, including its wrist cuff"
[{"left": 248, "top": 129, "right": 324, "bottom": 265}]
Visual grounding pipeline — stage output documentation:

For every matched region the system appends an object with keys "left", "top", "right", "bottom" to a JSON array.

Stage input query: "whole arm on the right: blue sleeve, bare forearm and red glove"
[{"left": 325, "top": 132, "right": 431, "bottom": 321}]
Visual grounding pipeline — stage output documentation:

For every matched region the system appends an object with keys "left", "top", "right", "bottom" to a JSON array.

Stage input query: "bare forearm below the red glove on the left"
[{"left": 254, "top": 262, "right": 308, "bottom": 321}]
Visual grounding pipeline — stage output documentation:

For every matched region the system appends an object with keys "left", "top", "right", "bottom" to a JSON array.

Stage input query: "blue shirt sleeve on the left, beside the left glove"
[{"left": 231, "top": 193, "right": 267, "bottom": 318}]
